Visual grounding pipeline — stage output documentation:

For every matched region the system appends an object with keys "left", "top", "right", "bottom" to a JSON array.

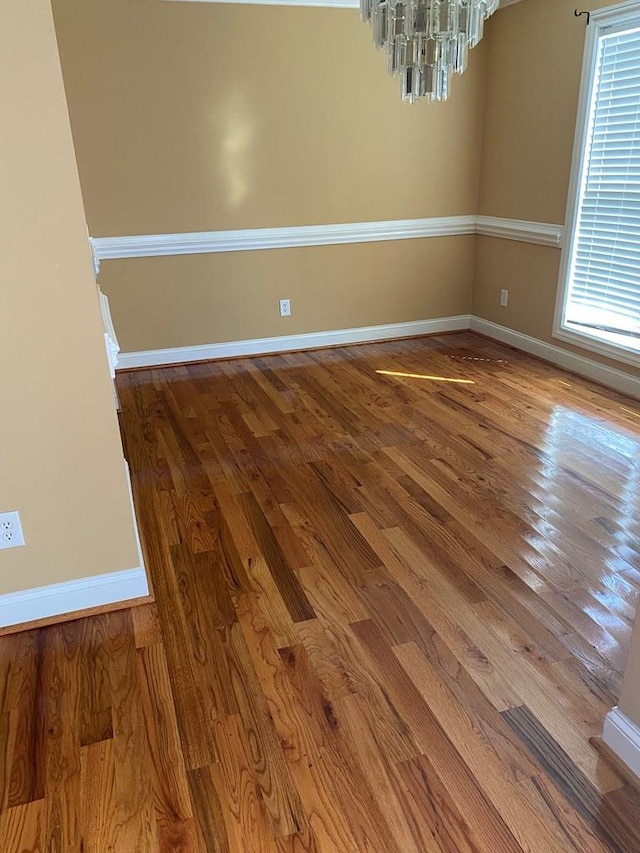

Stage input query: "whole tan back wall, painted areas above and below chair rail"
[{"left": 53, "top": 0, "right": 485, "bottom": 351}]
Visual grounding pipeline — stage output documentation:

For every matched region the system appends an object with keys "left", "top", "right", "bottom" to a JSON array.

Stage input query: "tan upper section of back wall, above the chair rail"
[{"left": 53, "top": 0, "right": 483, "bottom": 237}]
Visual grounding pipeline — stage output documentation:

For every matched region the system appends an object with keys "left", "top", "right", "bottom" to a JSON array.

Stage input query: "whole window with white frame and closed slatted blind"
[{"left": 555, "top": 0, "right": 640, "bottom": 363}]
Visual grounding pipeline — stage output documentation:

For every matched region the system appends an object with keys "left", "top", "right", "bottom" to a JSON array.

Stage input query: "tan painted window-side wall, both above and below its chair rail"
[{"left": 473, "top": 0, "right": 640, "bottom": 375}]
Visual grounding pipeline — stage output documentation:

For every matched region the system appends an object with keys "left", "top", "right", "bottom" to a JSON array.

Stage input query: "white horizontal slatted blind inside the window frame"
[{"left": 564, "top": 22, "right": 640, "bottom": 350}]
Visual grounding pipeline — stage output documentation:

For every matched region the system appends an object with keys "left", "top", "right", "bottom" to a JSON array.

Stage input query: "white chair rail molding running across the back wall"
[{"left": 89, "top": 216, "right": 476, "bottom": 265}]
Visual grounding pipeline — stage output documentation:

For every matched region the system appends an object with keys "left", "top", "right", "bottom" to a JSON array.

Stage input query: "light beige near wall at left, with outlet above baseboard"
[{"left": 0, "top": 0, "right": 138, "bottom": 594}]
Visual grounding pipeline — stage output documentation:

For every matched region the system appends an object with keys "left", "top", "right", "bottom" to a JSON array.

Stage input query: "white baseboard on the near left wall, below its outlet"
[{"left": 0, "top": 566, "right": 149, "bottom": 628}]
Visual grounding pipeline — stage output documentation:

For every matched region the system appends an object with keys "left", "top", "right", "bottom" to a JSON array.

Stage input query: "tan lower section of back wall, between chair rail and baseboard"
[{"left": 100, "top": 236, "right": 475, "bottom": 352}]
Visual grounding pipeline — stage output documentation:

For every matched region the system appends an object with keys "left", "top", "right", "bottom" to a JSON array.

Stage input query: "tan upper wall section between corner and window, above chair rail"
[{"left": 479, "top": 0, "right": 584, "bottom": 223}]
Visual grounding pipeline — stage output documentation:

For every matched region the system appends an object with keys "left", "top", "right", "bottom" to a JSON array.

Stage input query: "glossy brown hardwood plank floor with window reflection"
[{"left": 0, "top": 334, "right": 640, "bottom": 853}]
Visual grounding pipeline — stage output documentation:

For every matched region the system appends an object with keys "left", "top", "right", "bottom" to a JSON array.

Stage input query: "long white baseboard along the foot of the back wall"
[{"left": 118, "top": 314, "right": 469, "bottom": 370}]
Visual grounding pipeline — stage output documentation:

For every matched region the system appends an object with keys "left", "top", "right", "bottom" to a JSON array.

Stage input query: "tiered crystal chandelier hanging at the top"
[{"left": 360, "top": 0, "right": 499, "bottom": 101}]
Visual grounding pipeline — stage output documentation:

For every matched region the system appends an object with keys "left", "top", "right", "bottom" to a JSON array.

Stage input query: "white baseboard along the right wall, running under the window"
[{"left": 470, "top": 317, "right": 640, "bottom": 399}]
